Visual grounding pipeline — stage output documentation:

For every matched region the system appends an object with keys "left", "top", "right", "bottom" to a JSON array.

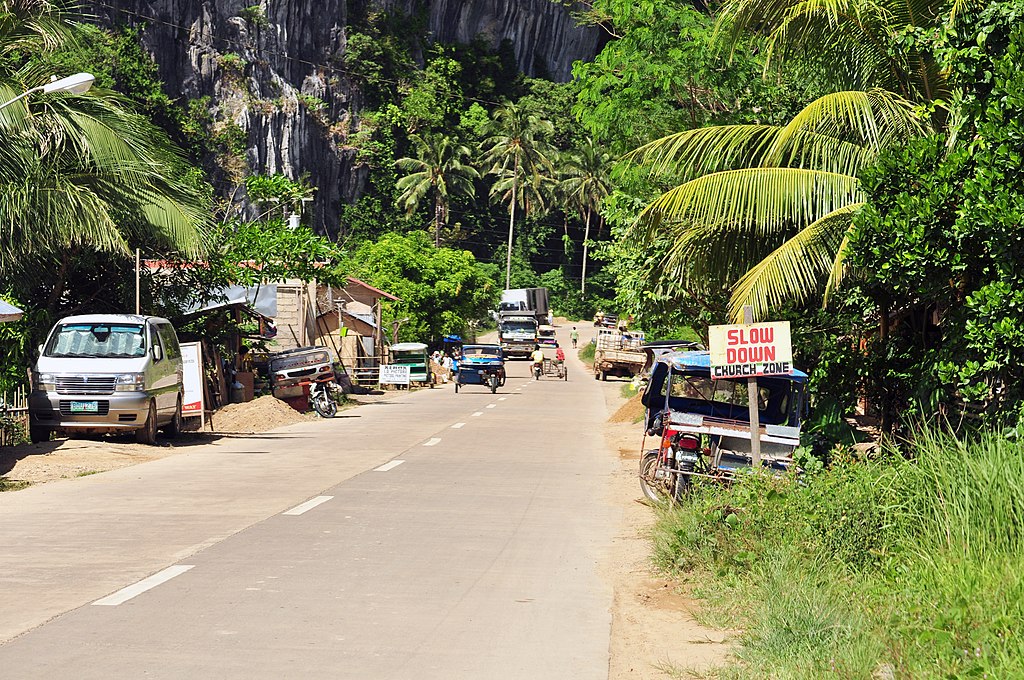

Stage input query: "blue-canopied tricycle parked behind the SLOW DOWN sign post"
[{"left": 640, "top": 351, "right": 807, "bottom": 503}]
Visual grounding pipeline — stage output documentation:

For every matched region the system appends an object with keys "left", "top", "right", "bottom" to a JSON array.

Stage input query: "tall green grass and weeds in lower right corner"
[{"left": 654, "top": 432, "right": 1024, "bottom": 678}]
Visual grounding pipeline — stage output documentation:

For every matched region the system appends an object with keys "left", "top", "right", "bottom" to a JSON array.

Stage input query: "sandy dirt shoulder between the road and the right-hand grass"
[{"left": 602, "top": 374, "right": 729, "bottom": 680}]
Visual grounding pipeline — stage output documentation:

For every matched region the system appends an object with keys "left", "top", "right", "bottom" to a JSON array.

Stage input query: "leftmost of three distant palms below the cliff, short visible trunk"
[{"left": 395, "top": 134, "right": 480, "bottom": 247}]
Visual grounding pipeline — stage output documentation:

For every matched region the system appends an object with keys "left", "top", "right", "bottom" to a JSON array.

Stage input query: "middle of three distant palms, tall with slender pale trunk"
[{"left": 483, "top": 103, "right": 554, "bottom": 289}]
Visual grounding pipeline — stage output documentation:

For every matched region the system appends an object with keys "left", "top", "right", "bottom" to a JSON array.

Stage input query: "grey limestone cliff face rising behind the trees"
[{"left": 93, "top": 0, "right": 601, "bottom": 232}]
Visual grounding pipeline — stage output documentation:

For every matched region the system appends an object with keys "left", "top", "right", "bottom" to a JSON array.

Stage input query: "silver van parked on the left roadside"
[{"left": 29, "top": 314, "right": 182, "bottom": 444}]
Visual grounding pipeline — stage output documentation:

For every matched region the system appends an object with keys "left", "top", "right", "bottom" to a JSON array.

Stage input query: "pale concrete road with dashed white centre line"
[{"left": 0, "top": 329, "right": 618, "bottom": 680}]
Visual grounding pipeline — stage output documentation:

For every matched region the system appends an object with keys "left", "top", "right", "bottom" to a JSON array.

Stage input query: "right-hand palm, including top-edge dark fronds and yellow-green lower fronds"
[{"left": 632, "top": 0, "right": 976, "bottom": 317}]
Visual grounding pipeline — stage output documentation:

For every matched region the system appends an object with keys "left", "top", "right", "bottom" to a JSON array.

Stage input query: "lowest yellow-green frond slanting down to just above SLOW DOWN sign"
[{"left": 729, "top": 204, "right": 860, "bottom": 320}]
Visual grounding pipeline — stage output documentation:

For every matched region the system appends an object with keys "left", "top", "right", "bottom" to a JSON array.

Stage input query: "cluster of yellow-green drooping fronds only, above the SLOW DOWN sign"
[{"left": 631, "top": 89, "right": 925, "bottom": 318}]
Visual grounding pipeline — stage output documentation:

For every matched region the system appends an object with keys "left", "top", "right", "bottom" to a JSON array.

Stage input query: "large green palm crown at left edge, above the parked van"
[{"left": 0, "top": 0, "right": 210, "bottom": 270}]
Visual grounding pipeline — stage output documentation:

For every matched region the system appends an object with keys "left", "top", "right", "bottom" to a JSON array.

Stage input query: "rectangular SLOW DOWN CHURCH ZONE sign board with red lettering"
[{"left": 708, "top": 322, "right": 793, "bottom": 378}]
